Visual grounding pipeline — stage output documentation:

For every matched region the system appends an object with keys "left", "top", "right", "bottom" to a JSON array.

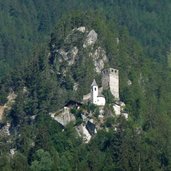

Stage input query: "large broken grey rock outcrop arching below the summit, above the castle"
[{"left": 51, "top": 26, "right": 108, "bottom": 75}]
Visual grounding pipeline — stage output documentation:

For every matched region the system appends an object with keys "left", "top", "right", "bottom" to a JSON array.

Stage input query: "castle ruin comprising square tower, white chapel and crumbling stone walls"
[{"left": 49, "top": 68, "right": 128, "bottom": 143}]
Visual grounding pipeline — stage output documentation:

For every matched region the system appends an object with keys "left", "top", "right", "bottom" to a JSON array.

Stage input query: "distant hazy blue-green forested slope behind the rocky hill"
[{"left": 0, "top": 0, "right": 171, "bottom": 76}]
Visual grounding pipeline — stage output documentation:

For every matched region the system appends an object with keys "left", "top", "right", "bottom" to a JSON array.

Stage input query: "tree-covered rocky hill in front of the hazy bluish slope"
[{"left": 0, "top": 8, "right": 171, "bottom": 171}]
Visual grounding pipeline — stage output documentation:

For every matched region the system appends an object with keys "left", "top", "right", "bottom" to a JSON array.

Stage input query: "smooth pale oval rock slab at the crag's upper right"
[{"left": 83, "top": 30, "right": 97, "bottom": 48}]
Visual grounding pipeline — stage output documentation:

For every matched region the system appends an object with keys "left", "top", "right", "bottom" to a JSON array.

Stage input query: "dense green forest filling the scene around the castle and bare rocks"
[{"left": 0, "top": 0, "right": 171, "bottom": 171}]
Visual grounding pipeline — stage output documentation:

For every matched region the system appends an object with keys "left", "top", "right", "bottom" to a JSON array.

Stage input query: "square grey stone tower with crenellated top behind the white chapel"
[{"left": 102, "top": 68, "right": 119, "bottom": 100}]
